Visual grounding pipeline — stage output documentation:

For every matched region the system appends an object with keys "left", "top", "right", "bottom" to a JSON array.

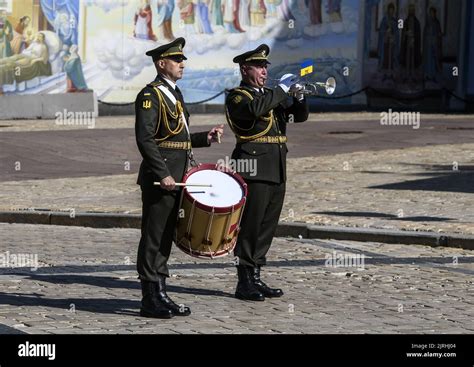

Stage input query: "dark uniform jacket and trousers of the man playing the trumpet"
[{"left": 226, "top": 82, "right": 309, "bottom": 268}]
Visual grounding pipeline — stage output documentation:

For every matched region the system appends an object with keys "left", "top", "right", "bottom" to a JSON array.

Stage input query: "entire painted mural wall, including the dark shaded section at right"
[{"left": 0, "top": 0, "right": 473, "bottom": 104}]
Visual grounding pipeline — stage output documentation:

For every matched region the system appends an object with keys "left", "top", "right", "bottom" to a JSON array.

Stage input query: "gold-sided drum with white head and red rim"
[{"left": 176, "top": 164, "right": 247, "bottom": 259}]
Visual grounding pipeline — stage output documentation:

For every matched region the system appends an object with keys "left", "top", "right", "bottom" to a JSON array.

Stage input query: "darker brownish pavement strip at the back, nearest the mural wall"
[{"left": 0, "top": 113, "right": 474, "bottom": 181}]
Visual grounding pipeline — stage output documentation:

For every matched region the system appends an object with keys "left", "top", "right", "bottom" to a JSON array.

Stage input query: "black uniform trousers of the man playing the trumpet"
[{"left": 234, "top": 181, "right": 286, "bottom": 267}]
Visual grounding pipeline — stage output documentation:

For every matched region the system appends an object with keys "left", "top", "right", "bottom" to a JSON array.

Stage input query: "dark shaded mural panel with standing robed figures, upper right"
[{"left": 364, "top": 0, "right": 464, "bottom": 95}]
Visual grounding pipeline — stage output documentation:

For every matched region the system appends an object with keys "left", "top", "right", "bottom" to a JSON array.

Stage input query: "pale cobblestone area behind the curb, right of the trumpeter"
[{"left": 283, "top": 144, "right": 474, "bottom": 234}]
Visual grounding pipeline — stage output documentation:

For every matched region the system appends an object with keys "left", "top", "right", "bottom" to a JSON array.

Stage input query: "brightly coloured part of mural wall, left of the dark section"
[{"left": 0, "top": 0, "right": 362, "bottom": 103}]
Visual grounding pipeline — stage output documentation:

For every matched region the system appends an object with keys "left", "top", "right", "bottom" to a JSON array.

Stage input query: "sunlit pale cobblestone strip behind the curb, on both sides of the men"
[{"left": 0, "top": 144, "right": 474, "bottom": 234}]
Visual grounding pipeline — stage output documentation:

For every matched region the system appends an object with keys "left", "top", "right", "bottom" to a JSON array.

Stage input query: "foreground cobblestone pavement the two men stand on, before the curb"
[{"left": 0, "top": 223, "right": 474, "bottom": 334}]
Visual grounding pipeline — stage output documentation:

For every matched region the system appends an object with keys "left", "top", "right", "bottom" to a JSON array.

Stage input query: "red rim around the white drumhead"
[{"left": 183, "top": 163, "right": 248, "bottom": 214}]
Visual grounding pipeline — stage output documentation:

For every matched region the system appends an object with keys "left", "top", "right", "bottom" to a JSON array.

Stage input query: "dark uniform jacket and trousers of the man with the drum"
[{"left": 135, "top": 76, "right": 210, "bottom": 282}]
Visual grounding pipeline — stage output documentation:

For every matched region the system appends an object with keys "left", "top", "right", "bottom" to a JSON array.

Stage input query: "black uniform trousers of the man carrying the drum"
[{"left": 137, "top": 187, "right": 180, "bottom": 282}]
